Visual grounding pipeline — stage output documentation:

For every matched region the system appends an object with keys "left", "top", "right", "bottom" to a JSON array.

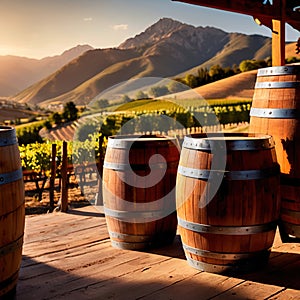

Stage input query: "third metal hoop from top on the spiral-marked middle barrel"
[{"left": 104, "top": 207, "right": 166, "bottom": 222}]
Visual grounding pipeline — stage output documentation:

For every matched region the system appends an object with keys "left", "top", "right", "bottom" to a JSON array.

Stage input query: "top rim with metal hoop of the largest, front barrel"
[{"left": 183, "top": 133, "right": 274, "bottom": 151}]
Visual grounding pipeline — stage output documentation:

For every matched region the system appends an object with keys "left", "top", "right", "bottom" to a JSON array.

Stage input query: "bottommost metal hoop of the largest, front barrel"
[{"left": 182, "top": 243, "right": 271, "bottom": 260}]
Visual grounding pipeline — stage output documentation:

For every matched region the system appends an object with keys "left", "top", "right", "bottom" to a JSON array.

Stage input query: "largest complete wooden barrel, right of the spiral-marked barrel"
[{"left": 176, "top": 134, "right": 280, "bottom": 273}]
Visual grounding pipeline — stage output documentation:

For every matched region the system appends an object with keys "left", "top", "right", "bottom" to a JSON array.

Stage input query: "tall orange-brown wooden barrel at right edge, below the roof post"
[{"left": 249, "top": 65, "right": 300, "bottom": 241}]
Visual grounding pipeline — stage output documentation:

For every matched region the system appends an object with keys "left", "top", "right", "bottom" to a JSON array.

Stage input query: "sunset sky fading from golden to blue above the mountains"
[{"left": 0, "top": 0, "right": 300, "bottom": 59}]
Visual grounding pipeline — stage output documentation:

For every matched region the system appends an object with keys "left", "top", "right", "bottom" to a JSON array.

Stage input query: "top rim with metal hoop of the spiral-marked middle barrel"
[{"left": 108, "top": 135, "right": 178, "bottom": 149}]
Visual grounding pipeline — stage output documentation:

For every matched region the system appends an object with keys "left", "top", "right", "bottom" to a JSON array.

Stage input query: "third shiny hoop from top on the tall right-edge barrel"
[{"left": 250, "top": 107, "right": 300, "bottom": 119}]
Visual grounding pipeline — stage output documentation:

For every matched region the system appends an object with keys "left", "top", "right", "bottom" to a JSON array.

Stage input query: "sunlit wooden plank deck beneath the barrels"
[{"left": 16, "top": 206, "right": 300, "bottom": 300}]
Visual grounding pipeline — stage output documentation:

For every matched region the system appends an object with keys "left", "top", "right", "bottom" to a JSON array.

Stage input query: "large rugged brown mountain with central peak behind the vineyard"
[{"left": 9, "top": 18, "right": 271, "bottom": 105}]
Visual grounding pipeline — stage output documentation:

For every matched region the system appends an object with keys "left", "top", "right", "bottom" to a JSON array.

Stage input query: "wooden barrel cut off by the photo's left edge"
[{"left": 0, "top": 126, "right": 25, "bottom": 299}]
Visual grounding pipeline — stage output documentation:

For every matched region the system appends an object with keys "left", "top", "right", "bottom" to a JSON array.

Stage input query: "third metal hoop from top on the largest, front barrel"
[{"left": 177, "top": 217, "right": 277, "bottom": 235}]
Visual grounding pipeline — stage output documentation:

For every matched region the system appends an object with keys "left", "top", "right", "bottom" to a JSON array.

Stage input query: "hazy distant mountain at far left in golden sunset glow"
[{"left": 0, "top": 45, "right": 93, "bottom": 97}]
